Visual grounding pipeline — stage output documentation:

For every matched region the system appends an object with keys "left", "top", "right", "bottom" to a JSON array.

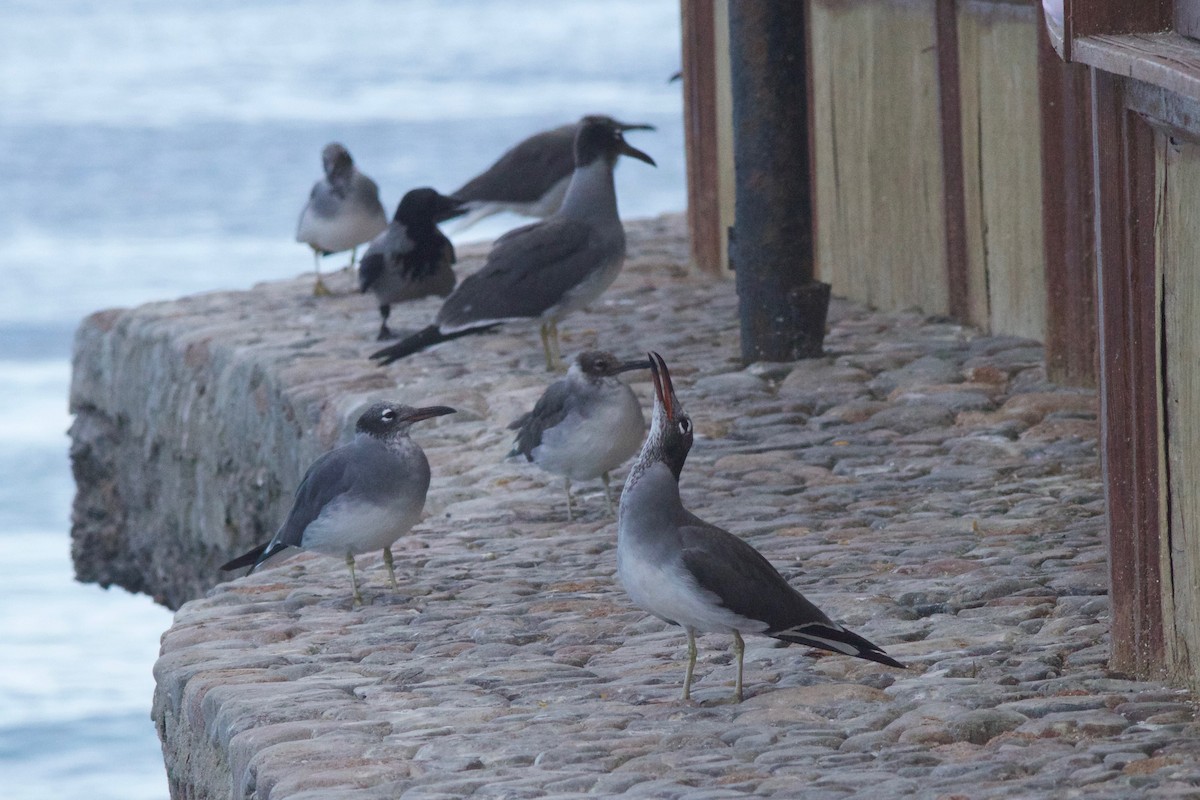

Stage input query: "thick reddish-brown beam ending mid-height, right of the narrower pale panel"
[{"left": 1038, "top": 1, "right": 1097, "bottom": 386}]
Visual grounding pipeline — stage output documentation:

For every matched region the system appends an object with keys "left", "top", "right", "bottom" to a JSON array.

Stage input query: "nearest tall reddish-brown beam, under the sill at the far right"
[{"left": 1092, "top": 71, "right": 1165, "bottom": 676}]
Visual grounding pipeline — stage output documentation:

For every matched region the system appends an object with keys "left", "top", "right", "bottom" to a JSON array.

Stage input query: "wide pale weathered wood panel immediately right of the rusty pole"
[{"left": 809, "top": 0, "right": 949, "bottom": 314}]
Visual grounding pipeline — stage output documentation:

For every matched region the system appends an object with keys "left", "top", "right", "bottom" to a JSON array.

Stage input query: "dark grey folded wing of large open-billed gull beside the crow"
[{"left": 437, "top": 218, "right": 596, "bottom": 331}]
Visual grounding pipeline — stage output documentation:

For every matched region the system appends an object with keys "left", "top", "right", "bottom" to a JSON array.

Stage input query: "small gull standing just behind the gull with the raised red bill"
[{"left": 509, "top": 350, "right": 650, "bottom": 519}]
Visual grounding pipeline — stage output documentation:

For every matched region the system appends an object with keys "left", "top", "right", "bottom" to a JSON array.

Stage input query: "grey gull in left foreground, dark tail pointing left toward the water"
[{"left": 221, "top": 403, "right": 455, "bottom": 604}]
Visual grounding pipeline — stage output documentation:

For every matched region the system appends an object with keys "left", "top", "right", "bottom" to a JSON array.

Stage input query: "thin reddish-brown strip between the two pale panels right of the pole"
[{"left": 935, "top": 0, "right": 969, "bottom": 327}]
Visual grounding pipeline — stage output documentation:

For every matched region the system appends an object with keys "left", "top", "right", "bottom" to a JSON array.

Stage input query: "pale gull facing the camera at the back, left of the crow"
[{"left": 296, "top": 142, "right": 388, "bottom": 296}]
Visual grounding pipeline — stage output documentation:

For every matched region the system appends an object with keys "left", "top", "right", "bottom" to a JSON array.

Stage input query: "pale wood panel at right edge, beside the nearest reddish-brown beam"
[{"left": 1154, "top": 133, "right": 1200, "bottom": 686}]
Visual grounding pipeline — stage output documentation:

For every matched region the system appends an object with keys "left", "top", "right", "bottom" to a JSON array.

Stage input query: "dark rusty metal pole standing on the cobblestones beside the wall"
[{"left": 730, "top": 0, "right": 829, "bottom": 362}]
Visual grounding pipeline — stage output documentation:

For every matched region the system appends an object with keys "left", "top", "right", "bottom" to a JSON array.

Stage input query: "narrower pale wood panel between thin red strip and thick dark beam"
[{"left": 958, "top": 2, "right": 1046, "bottom": 339}]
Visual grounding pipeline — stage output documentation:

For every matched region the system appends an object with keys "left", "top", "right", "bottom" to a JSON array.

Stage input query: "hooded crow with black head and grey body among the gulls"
[{"left": 359, "top": 187, "right": 466, "bottom": 339}]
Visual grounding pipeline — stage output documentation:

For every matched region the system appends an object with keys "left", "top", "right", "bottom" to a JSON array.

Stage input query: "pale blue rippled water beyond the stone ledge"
[{"left": 0, "top": 0, "right": 685, "bottom": 800}]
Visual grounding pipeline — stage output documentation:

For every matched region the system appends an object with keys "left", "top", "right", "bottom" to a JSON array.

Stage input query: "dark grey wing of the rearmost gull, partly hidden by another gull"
[{"left": 451, "top": 125, "right": 577, "bottom": 203}]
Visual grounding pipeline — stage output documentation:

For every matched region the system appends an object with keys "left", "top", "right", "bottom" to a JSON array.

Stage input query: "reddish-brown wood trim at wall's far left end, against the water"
[{"left": 679, "top": 0, "right": 722, "bottom": 273}]
